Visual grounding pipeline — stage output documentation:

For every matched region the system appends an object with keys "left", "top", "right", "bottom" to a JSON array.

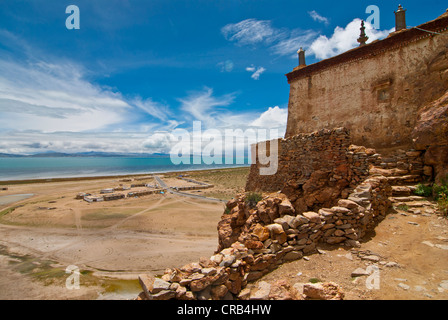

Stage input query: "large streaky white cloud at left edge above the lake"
[{"left": 0, "top": 60, "right": 131, "bottom": 132}]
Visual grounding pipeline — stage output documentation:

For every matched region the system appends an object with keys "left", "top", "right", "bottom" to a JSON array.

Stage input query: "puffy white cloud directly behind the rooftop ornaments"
[{"left": 309, "top": 18, "right": 392, "bottom": 59}]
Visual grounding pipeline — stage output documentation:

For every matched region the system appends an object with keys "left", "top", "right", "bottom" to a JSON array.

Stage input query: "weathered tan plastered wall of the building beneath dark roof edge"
[{"left": 286, "top": 15, "right": 448, "bottom": 150}]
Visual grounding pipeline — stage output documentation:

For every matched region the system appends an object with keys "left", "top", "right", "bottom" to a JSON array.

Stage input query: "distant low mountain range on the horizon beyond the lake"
[{"left": 0, "top": 151, "right": 170, "bottom": 158}]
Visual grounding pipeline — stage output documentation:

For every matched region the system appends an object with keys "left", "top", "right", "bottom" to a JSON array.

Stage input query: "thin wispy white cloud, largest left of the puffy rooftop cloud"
[{"left": 221, "top": 19, "right": 276, "bottom": 45}]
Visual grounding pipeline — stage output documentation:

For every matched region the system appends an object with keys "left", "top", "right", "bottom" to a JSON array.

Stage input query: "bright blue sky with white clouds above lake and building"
[{"left": 0, "top": 0, "right": 447, "bottom": 153}]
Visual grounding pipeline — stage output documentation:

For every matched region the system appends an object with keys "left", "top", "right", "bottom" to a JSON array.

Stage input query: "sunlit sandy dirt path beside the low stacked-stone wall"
[{"left": 255, "top": 205, "right": 448, "bottom": 300}]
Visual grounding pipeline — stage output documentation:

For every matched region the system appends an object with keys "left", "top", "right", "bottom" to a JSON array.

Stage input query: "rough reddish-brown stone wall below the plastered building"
[{"left": 246, "top": 128, "right": 376, "bottom": 212}]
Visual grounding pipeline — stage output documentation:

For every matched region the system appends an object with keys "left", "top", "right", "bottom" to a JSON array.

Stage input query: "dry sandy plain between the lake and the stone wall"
[{"left": 0, "top": 168, "right": 248, "bottom": 299}]
